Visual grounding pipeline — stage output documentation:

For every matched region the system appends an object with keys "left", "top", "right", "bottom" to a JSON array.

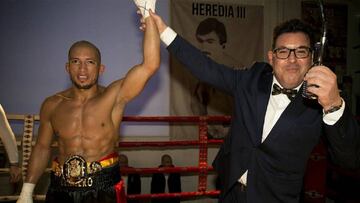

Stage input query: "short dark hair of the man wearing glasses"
[{"left": 272, "top": 19, "right": 315, "bottom": 49}]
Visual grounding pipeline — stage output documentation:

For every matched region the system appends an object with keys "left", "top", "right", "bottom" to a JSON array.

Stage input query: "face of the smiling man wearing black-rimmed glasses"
[{"left": 268, "top": 32, "right": 312, "bottom": 88}]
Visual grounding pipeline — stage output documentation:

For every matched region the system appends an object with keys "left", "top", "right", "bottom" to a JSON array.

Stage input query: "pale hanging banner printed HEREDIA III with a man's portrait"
[{"left": 170, "top": 0, "right": 264, "bottom": 140}]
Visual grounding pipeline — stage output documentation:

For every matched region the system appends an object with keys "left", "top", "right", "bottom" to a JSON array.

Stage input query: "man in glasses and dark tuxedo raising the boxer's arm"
[{"left": 142, "top": 15, "right": 360, "bottom": 203}]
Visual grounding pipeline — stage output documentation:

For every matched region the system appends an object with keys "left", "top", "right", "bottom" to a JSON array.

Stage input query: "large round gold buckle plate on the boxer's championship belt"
[{"left": 63, "top": 155, "right": 92, "bottom": 187}]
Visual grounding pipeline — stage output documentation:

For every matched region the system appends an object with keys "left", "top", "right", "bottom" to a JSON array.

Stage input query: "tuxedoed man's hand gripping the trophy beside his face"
[{"left": 304, "top": 66, "right": 342, "bottom": 111}]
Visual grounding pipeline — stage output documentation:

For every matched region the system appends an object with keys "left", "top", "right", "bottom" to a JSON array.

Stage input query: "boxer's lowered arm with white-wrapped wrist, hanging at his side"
[{"left": 17, "top": 98, "right": 54, "bottom": 203}]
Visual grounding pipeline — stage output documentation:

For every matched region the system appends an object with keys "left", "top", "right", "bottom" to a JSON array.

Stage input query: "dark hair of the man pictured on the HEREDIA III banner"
[{"left": 196, "top": 18, "right": 227, "bottom": 45}]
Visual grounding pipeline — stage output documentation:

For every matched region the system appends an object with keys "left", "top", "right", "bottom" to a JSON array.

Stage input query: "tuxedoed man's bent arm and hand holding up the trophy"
[{"left": 304, "top": 66, "right": 360, "bottom": 169}]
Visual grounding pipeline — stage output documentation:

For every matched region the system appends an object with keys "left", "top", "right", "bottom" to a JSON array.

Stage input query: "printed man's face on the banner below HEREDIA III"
[{"left": 196, "top": 31, "right": 224, "bottom": 59}]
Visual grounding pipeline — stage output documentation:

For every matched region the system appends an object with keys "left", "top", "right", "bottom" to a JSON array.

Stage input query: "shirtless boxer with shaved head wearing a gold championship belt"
[{"left": 18, "top": 7, "right": 160, "bottom": 203}]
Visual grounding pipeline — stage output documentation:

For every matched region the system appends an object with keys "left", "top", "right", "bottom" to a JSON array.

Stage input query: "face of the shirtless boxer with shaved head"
[{"left": 66, "top": 46, "right": 104, "bottom": 89}]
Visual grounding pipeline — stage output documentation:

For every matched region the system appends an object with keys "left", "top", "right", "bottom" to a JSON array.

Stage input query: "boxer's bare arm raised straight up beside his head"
[{"left": 117, "top": 12, "right": 160, "bottom": 103}]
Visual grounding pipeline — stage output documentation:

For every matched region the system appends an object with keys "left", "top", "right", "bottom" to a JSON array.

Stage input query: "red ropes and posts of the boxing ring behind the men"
[{"left": 0, "top": 114, "right": 334, "bottom": 203}]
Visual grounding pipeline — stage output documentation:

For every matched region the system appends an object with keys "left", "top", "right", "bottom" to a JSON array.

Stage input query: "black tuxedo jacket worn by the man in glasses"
[{"left": 168, "top": 35, "right": 359, "bottom": 203}]
